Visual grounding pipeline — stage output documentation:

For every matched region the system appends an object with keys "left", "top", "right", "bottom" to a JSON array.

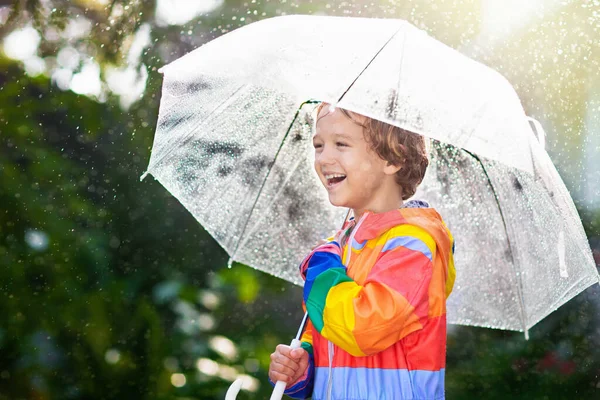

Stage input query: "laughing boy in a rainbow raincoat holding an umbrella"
[{"left": 269, "top": 103, "right": 455, "bottom": 400}]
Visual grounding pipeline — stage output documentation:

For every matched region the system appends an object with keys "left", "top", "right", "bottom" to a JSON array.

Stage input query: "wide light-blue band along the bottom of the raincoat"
[{"left": 312, "top": 367, "right": 445, "bottom": 400}]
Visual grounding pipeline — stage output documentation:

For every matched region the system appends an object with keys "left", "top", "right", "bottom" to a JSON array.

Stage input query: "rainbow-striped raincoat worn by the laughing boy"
[{"left": 285, "top": 202, "right": 455, "bottom": 400}]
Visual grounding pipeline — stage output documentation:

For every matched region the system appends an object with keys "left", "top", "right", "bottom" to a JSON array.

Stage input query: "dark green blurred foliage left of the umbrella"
[{"left": 0, "top": 61, "right": 297, "bottom": 399}]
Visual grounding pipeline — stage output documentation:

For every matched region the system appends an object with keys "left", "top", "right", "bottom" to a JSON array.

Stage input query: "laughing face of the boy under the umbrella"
[{"left": 313, "top": 105, "right": 401, "bottom": 215}]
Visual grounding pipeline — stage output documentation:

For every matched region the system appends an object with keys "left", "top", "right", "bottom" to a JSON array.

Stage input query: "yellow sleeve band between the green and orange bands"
[{"left": 321, "top": 282, "right": 365, "bottom": 357}]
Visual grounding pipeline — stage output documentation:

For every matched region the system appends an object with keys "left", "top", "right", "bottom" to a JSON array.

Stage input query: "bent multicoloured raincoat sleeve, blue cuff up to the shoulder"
[{"left": 303, "top": 226, "right": 438, "bottom": 356}]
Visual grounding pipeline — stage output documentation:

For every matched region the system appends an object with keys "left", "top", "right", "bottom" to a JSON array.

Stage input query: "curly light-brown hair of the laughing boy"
[{"left": 316, "top": 103, "right": 429, "bottom": 200}]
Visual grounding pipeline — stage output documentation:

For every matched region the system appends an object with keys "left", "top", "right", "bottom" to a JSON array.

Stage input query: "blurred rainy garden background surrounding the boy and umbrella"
[{"left": 0, "top": 0, "right": 600, "bottom": 399}]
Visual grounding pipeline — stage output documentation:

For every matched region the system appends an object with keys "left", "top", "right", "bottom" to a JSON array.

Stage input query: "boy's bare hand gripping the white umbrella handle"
[{"left": 269, "top": 344, "right": 308, "bottom": 385}]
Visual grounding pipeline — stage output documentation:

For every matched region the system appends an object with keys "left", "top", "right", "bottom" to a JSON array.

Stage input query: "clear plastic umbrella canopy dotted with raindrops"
[{"left": 142, "top": 16, "right": 599, "bottom": 333}]
